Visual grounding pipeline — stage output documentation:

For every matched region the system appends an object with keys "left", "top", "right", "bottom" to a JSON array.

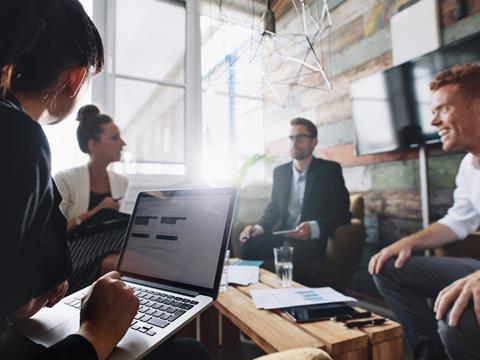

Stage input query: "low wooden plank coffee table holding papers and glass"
[{"left": 182, "top": 269, "right": 404, "bottom": 360}]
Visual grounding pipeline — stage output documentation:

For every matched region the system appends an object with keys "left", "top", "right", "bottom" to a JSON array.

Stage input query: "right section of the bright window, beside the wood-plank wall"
[{"left": 201, "top": 15, "right": 265, "bottom": 183}]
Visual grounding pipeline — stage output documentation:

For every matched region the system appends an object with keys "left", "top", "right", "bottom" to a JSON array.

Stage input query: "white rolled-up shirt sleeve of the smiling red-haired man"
[{"left": 438, "top": 164, "right": 480, "bottom": 240}]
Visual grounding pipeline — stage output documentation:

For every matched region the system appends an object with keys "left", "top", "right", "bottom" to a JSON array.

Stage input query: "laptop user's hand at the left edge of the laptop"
[{"left": 8, "top": 281, "right": 68, "bottom": 322}]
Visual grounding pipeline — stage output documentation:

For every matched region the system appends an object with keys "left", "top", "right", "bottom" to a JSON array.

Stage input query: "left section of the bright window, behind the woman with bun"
[{"left": 45, "top": 0, "right": 202, "bottom": 177}]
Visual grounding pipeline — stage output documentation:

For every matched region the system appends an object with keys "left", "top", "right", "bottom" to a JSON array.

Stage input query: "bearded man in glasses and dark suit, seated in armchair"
[{"left": 240, "top": 118, "right": 351, "bottom": 285}]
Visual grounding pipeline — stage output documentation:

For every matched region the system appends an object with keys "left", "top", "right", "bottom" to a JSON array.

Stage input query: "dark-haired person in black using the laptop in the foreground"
[{"left": 0, "top": 0, "right": 208, "bottom": 359}]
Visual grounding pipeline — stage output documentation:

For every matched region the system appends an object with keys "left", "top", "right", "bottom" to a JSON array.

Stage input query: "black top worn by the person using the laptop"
[{"left": 0, "top": 95, "right": 97, "bottom": 359}]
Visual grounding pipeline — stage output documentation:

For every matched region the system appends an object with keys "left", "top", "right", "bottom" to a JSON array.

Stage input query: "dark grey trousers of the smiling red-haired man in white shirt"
[{"left": 374, "top": 256, "right": 480, "bottom": 360}]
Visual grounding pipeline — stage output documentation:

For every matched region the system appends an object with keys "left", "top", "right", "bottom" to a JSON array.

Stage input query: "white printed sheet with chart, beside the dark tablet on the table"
[{"left": 250, "top": 287, "right": 356, "bottom": 309}]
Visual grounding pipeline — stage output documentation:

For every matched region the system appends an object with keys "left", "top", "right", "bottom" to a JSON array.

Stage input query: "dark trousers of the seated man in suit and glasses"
[{"left": 240, "top": 234, "right": 322, "bottom": 285}]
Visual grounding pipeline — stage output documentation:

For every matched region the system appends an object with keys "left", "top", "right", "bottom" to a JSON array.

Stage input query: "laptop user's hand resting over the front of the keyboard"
[{"left": 78, "top": 271, "right": 139, "bottom": 360}]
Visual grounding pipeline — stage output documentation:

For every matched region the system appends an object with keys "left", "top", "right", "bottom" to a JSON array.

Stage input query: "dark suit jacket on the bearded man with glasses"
[{"left": 259, "top": 158, "right": 352, "bottom": 240}]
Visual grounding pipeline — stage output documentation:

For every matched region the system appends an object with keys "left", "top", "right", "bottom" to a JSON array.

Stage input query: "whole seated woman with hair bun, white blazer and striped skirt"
[{"left": 54, "top": 105, "right": 128, "bottom": 282}]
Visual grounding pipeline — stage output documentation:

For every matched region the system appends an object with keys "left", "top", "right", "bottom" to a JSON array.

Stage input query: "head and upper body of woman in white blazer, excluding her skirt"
[{"left": 54, "top": 105, "right": 128, "bottom": 231}]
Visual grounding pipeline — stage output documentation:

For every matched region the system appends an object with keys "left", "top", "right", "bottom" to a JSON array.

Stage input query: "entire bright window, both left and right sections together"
[{"left": 46, "top": 0, "right": 264, "bottom": 184}]
